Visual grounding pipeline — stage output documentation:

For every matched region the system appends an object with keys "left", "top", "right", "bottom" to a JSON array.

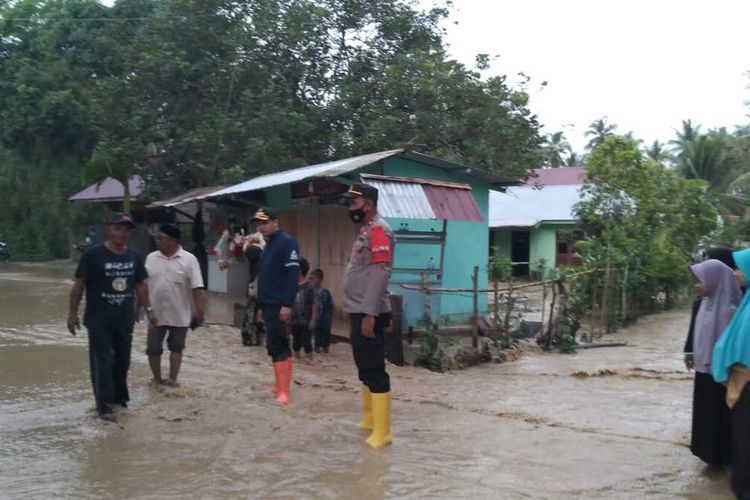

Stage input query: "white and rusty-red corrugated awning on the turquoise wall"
[{"left": 361, "top": 174, "right": 484, "bottom": 222}]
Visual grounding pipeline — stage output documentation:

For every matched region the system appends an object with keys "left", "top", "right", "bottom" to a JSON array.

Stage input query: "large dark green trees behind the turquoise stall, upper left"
[{"left": 0, "top": 0, "right": 541, "bottom": 258}]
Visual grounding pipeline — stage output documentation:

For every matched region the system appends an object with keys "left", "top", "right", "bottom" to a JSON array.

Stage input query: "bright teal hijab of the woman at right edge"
[{"left": 711, "top": 249, "right": 750, "bottom": 382}]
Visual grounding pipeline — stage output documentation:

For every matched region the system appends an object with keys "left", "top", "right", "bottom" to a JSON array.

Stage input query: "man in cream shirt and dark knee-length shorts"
[{"left": 146, "top": 224, "right": 203, "bottom": 385}]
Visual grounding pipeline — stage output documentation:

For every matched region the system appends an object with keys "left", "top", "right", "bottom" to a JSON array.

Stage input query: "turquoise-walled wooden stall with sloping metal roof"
[{"left": 192, "top": 149, "right": 511, "bottom": 326}]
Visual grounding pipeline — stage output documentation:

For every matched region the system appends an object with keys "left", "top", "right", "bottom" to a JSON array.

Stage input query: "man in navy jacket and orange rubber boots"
[{"left": 253, "top": 207, "right": 299, "bottom": 405}]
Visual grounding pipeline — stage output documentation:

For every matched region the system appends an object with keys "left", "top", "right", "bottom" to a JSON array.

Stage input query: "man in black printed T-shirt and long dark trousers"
[{"left": 68, "top": 213, "right": 156, "bottom": 422}]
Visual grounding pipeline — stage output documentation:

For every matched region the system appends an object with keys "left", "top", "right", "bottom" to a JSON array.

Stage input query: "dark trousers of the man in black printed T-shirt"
[{"left": 88, "top": 322, "right": 133, "bottom": 414}]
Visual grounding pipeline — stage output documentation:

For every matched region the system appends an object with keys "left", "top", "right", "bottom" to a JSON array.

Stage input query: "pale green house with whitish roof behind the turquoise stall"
[{"left": 489, "top": 167, "right": 584, "bottom": 279}]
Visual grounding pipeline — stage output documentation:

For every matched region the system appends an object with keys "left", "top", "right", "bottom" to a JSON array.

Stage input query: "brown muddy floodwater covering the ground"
[{"left": 0, "top": 264, "right": 732, "bottom": 500}]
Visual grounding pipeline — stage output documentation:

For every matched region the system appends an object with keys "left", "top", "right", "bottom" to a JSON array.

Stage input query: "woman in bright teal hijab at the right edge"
[{"left": 711, "top": 249, "right": 750, "bottom": 499}]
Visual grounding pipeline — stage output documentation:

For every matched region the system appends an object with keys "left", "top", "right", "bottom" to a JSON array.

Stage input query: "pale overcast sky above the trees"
[{"left": 438, "top": 0, "right": 750, "bottom": 152}]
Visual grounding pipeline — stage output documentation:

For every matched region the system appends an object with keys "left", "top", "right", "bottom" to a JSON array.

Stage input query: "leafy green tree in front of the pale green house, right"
[{"left": 570, "top": 136, "right": 717, "bottom": 330}]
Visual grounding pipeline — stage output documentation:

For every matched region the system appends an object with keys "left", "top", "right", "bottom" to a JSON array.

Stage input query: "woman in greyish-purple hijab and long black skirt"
[{"left": 690, "top": 259, "right": 742, "bottom": 466}]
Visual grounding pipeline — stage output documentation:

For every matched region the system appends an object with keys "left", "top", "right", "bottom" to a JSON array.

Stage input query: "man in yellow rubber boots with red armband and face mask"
[{"left": 342, "top": 184, "right": 395, "bottom": 448}]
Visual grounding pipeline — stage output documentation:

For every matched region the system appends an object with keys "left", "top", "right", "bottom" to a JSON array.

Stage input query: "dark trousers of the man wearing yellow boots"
[{"left": 350, "top": 313, "right": 391, "bottom": 393}]
